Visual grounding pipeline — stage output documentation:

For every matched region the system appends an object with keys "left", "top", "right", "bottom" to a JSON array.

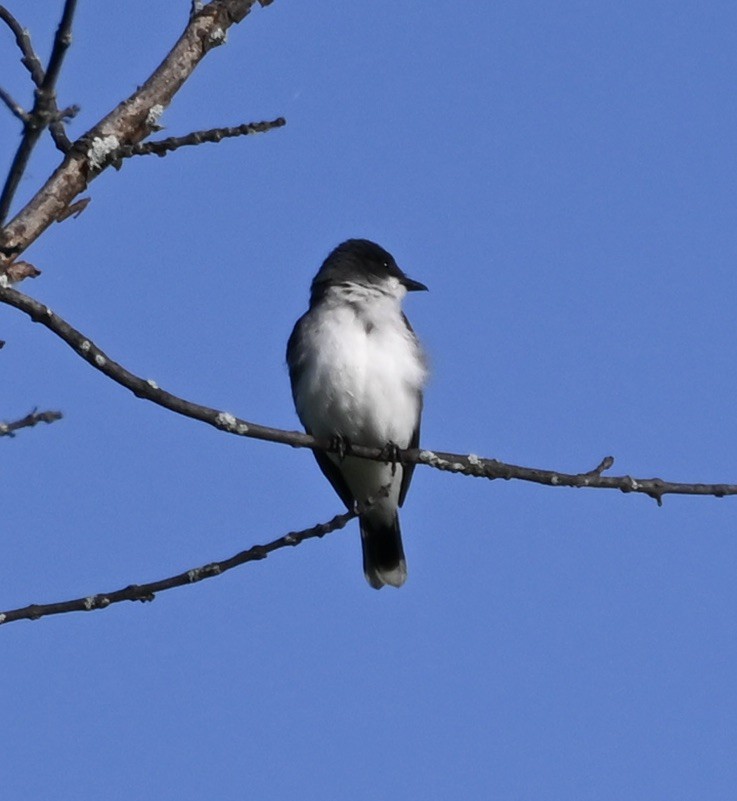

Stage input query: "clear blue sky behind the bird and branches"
[{"left": 0, "top": 0, "right": 737, "bottom": 801}]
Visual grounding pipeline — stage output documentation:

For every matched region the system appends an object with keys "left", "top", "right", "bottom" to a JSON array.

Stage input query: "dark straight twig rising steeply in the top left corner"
[{"left": 0, "top": 0, "right": 77, "bottom": 226}]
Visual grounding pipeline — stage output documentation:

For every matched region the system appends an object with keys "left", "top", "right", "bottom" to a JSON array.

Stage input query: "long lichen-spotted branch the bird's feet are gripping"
[{"left": 0, "top": 281, "right": 737, "bottom": 505}]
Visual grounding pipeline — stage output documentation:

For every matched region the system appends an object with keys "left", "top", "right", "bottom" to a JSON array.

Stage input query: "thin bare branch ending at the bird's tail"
[{"left": 0, "top": 505, "right": 360, "bottom": 624}]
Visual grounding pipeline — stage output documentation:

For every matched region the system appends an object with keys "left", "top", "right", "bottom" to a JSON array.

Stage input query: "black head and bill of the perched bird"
[{"left": 312, "top": 239, "right": 427, "bottom": 302}]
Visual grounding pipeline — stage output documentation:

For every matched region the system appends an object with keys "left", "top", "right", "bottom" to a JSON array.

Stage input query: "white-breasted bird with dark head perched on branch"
[{"left": 287, "top": 239, "right": 428, "bottom": 589}]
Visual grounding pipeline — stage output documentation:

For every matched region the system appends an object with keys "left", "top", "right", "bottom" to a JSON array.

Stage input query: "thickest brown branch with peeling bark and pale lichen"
[{"left": 0, "top": 0, "right": 271, "bottom": 258}]
